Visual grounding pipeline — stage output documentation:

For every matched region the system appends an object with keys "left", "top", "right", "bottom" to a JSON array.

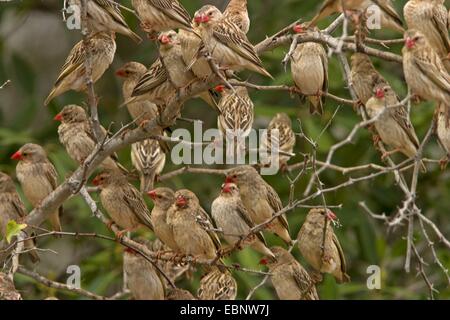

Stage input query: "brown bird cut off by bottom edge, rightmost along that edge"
[{"left": 261, "top": 247, "right": 319, "bottom": 300}]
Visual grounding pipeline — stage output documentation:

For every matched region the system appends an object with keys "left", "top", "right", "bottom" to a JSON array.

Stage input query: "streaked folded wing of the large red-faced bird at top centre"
[{"left": 213, "top": 20, "right": 262, "bottom": 67}]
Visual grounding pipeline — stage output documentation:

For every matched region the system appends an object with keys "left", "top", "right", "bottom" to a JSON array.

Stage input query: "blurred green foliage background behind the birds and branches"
[{"left": 0, "top": 0, "right": 450, "bottom": 299}]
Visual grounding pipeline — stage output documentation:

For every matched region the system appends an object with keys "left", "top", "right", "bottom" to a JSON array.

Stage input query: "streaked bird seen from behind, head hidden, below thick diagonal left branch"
[{"left": 131, "top": 139, "right": 166, "bottom": 193}]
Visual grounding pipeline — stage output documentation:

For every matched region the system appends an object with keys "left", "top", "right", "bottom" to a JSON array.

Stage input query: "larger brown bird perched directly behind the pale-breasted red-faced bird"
[{"left": 225, "top": 166, "right": 292, "bottom": 244}]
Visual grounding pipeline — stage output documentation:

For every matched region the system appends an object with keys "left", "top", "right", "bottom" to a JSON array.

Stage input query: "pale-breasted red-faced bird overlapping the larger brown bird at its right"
[{"left": 211, "top": 183, "right": 274, "bottom": 257}]
